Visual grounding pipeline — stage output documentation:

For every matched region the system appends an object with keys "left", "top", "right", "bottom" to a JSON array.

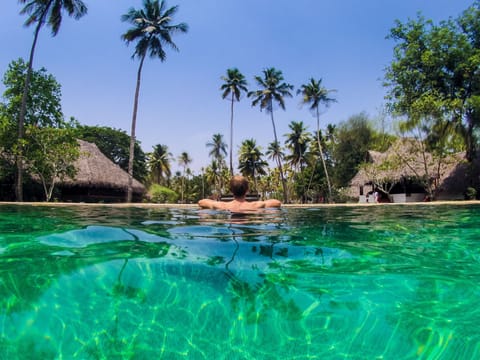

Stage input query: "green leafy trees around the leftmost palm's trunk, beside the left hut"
[{"left": 0, "top": 59, "right": 78, "bottom": 201}]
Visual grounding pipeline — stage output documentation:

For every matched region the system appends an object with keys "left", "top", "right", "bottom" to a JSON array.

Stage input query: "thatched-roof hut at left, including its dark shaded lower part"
[{"left": 58, "top": 140, "right": 146, "bottom": 202}]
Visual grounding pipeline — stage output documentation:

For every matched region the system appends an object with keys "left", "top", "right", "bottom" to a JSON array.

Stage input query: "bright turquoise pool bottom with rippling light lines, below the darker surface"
[{"left": 0, "top": 259, "right": 480, "bottom": 359}]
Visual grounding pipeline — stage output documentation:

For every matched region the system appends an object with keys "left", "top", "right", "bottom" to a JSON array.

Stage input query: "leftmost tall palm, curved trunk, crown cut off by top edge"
[{"left": 15, "top": 0, "right": 87, "bottom": 201}]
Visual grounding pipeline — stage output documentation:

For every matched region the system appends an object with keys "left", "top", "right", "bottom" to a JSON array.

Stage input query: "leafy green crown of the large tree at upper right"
[{"left": 385, "top": 1, "right": 480, "bottom": 161}]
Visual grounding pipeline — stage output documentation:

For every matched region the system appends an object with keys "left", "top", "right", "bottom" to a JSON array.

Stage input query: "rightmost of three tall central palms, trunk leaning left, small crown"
[{"left": 297, "top": 78, "right": 336, "bottom": 201}]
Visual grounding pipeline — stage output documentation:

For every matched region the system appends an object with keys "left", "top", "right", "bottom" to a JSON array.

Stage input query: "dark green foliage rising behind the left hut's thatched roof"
[{"left": 75, "top": 125, "right": 148, "bottom": 182}]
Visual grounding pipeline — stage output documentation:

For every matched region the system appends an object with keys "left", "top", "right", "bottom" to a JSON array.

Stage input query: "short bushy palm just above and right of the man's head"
[{"left": 238, "top": 139, "right": 268, "bottom": 190}]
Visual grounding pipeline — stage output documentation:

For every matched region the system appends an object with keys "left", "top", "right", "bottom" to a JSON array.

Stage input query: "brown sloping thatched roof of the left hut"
[{"left": 61, "top": 140, "right": 145, "bottom": 193}]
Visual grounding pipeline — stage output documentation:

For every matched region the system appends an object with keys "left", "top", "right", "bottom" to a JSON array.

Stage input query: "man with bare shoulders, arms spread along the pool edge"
[{"left": 198, "top": 175, "right": 282, "bottom": 212}]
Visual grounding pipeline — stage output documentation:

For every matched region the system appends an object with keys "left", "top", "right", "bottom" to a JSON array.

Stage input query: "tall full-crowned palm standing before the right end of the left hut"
[{"left": 121, "top": 0, "right": 188, "bottom": 202}]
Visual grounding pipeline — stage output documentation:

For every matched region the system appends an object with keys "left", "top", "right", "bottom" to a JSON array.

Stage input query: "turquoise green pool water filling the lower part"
[{"left": 0, "top": 205, "right": 480, "bottom": 360}]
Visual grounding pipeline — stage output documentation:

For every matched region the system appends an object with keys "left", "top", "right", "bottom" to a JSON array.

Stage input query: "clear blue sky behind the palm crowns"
[{"left": 0, "top": 0, "right": 473, "bottom": 172}]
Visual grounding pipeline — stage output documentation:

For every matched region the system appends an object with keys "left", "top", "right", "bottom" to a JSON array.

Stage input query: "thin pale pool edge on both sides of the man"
[{"left": 0, "top": 200, "right": 480, "bottom": 209}]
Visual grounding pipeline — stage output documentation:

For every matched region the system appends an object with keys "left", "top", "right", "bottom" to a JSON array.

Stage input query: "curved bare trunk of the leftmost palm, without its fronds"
[{"left": 15, "top": 5, "right": 52, "bottom": 202}]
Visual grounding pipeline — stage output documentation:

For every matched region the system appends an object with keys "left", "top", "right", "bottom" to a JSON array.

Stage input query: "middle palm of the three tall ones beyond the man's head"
[{"left": 247, "top": 67, "right": 293, "bottom": 203}]
